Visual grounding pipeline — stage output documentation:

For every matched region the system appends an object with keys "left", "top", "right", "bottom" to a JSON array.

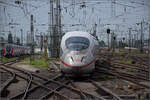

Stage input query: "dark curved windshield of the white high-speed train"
[{"left": 65, "top": 37, "right": 90, "bottom": 51}]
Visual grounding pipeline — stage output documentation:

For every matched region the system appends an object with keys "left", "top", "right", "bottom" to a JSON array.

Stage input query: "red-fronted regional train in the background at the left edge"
[{"left": 0, "top": 43, "right": 30, "bottom": 57}]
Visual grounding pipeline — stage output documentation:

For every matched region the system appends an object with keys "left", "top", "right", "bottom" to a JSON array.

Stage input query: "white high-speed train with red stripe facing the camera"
[{"left": 60, "top": 31, "right": 99, "bottom": 75}]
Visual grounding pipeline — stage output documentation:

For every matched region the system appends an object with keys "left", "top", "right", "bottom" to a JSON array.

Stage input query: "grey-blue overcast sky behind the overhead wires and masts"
[{"left": 0, "top": 0, "right": 150, "bottom": 41}]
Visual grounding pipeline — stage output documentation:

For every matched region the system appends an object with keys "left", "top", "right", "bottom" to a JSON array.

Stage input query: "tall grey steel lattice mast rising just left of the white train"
[{"left": 48, "top": 0, "right": 62, "bottom": 57}]
